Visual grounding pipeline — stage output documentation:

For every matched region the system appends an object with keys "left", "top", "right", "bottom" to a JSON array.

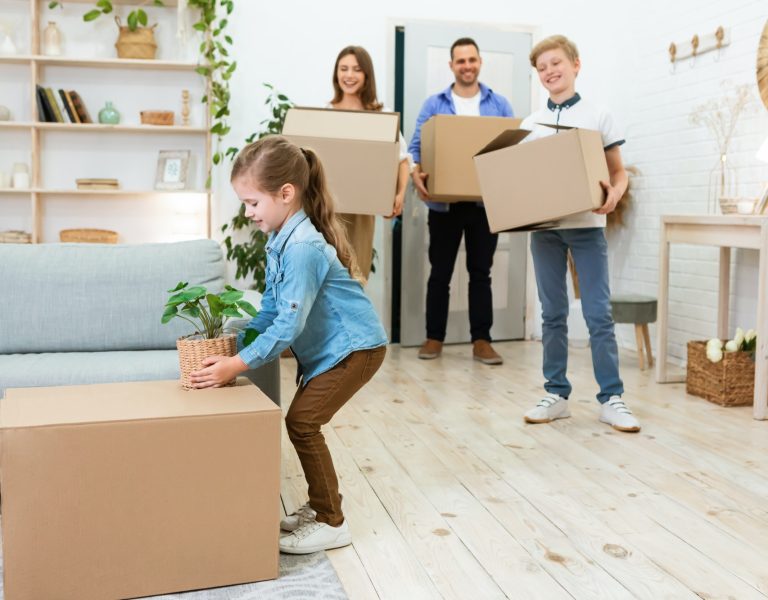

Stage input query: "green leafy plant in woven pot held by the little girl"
[{"left": 161, "top": 281, "right": 258, "bottom": 390}]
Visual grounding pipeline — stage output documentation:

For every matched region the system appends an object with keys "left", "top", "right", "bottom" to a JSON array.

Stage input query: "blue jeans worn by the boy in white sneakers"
[{"left": 531, "top": 227, "right": 624, "bottom": 404}]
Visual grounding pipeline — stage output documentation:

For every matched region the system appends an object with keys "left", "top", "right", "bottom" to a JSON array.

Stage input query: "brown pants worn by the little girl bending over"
[{"left": 285, "top": 346, "right": 387, "bottom": 527}]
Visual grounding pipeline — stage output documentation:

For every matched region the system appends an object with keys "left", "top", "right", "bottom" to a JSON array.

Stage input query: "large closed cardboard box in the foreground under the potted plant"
[{"left": 0, "top": 380, "right": 281, "bottom": 600}]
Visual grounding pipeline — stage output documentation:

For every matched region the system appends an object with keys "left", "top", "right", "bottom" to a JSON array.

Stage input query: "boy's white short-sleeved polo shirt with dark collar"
[{"left": 520, "top": 94, "right": 624, "bottom": 229}]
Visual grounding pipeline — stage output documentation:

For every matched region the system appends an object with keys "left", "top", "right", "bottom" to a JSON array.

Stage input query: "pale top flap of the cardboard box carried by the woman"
[{"left": 283, "top": 106, "right": 400, "bottom": 142}]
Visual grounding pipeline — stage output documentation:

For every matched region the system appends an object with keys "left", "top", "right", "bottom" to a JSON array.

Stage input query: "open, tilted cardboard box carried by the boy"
[{"left": 475, "top": 127, "right": 609, "bottom": 233}]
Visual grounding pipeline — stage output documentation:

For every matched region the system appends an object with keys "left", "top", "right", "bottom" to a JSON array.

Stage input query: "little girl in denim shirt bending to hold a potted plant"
[{"left": 191, "top": 136, "right": 387, "bottom": 554}]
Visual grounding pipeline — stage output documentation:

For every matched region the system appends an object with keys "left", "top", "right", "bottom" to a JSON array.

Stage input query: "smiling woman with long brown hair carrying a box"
[{"left": 328, "top": 46, "right": 410, "bottom": 281}]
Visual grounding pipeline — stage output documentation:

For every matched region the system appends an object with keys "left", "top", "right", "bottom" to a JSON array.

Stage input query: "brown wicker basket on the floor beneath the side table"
[{"left": 685, "top": 342, "right": 755, "bottom": 406}]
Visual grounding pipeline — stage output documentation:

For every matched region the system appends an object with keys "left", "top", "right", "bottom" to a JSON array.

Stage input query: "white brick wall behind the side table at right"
[{"left": 609, "top": 0, "right": 768, "bottom": 363}]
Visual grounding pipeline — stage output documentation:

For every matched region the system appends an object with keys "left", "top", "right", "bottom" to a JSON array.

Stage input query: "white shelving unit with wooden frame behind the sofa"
[{"left": 0, "top": 0, "right": 212, "bottom": 243}]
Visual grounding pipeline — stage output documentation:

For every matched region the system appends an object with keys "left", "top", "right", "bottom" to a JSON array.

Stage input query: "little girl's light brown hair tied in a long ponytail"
[{"left": 230, "top": 135, "right": 360, "bottom": 279}]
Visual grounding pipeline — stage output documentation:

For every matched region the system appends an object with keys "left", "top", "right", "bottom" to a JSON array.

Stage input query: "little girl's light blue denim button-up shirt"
[{"left": 238, "top": 211, "right": 387, "bottom": 383}]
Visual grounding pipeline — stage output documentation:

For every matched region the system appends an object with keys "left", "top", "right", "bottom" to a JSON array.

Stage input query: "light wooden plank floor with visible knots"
[{"left": 282, "top": 342, "right": 768, "bottom": 600}]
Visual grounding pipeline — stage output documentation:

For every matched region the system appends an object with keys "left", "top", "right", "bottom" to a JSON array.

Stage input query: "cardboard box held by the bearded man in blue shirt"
[{"left": 421, "top": 115, "right": 520, "bottom": 202}]
